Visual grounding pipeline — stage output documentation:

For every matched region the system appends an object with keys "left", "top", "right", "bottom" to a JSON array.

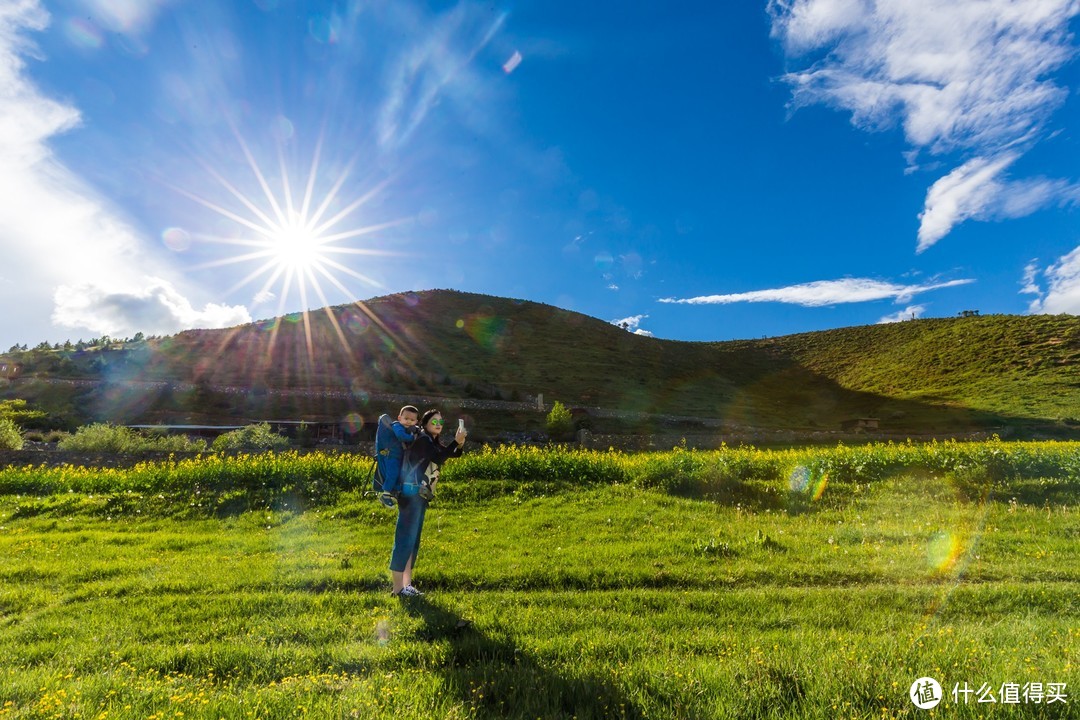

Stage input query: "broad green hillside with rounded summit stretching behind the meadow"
[{"left": 3, "top": 290, "right": 1080, "bottom": 433}]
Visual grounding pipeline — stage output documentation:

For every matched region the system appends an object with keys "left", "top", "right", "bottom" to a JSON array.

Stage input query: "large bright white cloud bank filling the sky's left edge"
[{"left": 0, "top": 0, "right": 246, "bottom": 341}]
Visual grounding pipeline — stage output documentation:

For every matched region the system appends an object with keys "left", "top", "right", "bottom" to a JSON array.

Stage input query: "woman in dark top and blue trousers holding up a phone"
[{"left": 390, "top": 410, "right": 465, "bottom": 597}]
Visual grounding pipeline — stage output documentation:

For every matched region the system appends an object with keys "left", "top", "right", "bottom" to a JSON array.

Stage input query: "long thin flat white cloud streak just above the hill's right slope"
[{"left": 660, "top": 277, "right": 975, "bottom": 308}]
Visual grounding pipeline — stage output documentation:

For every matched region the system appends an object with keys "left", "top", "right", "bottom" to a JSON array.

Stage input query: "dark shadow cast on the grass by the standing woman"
[{"left": 402, "top": 598, "right": 643, "bottom": 720}]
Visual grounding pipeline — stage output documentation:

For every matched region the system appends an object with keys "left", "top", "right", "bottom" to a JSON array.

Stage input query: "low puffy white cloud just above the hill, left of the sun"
[{"left": 53, "top": 277, "right": 252, "bottom": 337}]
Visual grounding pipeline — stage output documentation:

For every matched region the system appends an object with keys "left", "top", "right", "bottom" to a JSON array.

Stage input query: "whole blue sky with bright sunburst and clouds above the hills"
[{"left": 0, "top": 0, "right": 1080, "bottom": 349}]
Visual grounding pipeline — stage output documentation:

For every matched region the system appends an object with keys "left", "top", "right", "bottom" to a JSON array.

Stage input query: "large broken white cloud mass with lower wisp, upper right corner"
[{"left": 769, "top": 0, "right": 1080, "bottom": 250}]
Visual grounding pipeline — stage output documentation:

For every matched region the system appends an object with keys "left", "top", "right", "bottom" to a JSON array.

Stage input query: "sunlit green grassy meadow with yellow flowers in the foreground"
[{"left": 0, "top": 441, "right": 1080, "bottom": 720}]
